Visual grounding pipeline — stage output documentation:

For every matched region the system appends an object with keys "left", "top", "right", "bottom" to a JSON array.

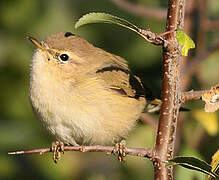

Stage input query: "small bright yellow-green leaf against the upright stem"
[{"left": 176, "top": 29, "right": 195, "bottom": 56}]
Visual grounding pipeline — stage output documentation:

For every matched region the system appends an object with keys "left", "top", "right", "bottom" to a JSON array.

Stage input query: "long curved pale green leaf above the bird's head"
[{"left": 75, "top": 13, "right": 140, "bottom": 34}]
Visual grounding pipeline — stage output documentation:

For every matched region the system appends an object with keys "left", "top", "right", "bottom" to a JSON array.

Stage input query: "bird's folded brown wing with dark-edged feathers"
[{"left": 96, "top": 56, "right": 145, "bottom": 99}]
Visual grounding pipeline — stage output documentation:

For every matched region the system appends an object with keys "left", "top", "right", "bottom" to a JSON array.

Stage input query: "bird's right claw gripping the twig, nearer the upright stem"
[{"left": 112, "top": 140, "right": 126, "bottom": 162}]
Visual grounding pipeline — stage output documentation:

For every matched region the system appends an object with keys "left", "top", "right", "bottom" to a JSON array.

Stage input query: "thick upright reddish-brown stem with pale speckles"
[{"left": 154, "top": 0, "right": 185, "bottom": 180}]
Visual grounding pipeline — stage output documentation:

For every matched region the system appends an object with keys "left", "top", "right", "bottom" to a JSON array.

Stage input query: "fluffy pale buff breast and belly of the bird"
[{"left": 30, "top": 52, "right": 145, "bottom": 145}]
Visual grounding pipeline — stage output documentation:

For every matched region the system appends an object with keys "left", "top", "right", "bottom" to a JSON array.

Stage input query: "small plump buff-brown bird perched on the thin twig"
[{"left": 29, "top": 32, "right": 151, "bottom": 146}]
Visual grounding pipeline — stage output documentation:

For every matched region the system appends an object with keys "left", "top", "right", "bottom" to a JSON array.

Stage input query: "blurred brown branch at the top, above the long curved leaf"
[{"left": 110, "top": 0, "right": 167, "bottom": 20}]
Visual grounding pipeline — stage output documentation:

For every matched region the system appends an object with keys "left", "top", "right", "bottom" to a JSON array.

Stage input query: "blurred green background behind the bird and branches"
[{"left": 0, "top": 0, "right": 219, "bottom": 180}]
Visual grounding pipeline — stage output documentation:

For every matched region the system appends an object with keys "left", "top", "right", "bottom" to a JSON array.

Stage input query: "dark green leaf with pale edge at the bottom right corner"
[{"left": 166, "top": 156, "right": 217, "bottom": 177}]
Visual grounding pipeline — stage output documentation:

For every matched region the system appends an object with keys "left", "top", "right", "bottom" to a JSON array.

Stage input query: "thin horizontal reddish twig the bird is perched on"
[{"left": 8, "top": 145, "right": 153, "bottom": 158}]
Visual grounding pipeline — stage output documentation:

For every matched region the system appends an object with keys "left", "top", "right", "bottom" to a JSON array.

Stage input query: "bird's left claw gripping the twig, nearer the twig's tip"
[{"left": 51, "top": 141, "right": 65, "bottom": 163}]
